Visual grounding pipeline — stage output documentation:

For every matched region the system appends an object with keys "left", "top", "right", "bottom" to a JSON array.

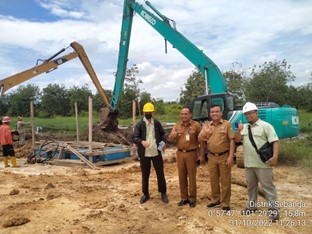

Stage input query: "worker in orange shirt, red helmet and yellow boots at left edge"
[{"left": 0, "top": 116, "right": 20, "bottom": 167}]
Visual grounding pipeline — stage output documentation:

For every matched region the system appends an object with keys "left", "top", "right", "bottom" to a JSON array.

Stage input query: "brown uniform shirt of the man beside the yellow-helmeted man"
[{"left": 173, "top": 120, "right": 201, "bottom": 150}]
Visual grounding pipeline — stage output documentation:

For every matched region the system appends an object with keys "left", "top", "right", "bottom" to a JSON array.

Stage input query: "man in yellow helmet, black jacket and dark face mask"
[{"left": 132, "top": 103, "right": 168, "bottom": 204}]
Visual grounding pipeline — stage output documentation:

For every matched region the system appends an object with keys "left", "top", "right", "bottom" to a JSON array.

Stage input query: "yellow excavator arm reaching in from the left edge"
[{"left": 0, "top": 42, "right": 110, "bottom": 108}]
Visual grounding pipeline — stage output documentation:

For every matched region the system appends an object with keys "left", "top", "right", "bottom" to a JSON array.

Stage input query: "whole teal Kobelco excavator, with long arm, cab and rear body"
[{"left": 111, "top": 0, "right": 299, "bottom": 138}]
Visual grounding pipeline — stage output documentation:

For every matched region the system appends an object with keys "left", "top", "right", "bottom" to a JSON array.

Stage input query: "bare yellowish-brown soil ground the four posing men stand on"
[{"left": 0, "top": 140, "right": 312, "bottom": 234}]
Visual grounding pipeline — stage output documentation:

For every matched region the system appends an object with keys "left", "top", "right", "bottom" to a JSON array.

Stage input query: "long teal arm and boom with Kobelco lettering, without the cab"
[{"left": 111, "top": 0, "right": 227, "bottom": 109}]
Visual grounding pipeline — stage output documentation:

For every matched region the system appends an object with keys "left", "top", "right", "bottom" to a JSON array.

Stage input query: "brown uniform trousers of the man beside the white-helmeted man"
[{"left": 208, "top": 153, "right": 231, "bottom": 207}]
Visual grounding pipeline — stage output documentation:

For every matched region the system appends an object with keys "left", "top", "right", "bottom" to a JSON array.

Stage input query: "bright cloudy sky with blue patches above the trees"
[{"left": 0, "top": 0, "right": 312, "bottom": 101}]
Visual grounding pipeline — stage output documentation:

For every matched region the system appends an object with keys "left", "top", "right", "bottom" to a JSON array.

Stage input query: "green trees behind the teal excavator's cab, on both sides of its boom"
[{"left": 180, "top": 60, "right": 312, "bottom": 112}]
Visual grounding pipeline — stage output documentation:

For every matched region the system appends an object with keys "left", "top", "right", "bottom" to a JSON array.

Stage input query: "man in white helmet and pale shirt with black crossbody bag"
[{"left": 235, "top": 102, "right": 280, "bottom": 222}]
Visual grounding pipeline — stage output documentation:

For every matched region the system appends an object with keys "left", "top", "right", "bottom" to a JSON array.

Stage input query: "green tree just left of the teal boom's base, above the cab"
[{"left": 180, "top": 70, "right": 205, "bottom": 105}]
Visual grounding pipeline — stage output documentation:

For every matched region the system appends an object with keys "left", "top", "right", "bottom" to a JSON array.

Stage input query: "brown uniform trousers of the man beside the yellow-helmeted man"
[{"left": 177, "top": 150, "right": 197, "bottom": 202}]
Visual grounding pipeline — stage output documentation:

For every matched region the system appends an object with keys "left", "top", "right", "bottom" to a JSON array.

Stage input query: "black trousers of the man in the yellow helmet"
[{"left": 140, "top": 155, "right": 167, "bottom": 195}]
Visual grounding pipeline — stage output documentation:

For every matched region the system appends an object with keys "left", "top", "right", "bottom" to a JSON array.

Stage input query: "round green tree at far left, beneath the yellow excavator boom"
[{"left": 8, "top": 84, "right": 41, "bottom": 116}]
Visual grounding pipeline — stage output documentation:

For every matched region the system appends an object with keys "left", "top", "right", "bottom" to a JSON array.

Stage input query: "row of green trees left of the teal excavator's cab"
[{"left": 0, "top": 65, "right": 164, "bottom": 118}]
